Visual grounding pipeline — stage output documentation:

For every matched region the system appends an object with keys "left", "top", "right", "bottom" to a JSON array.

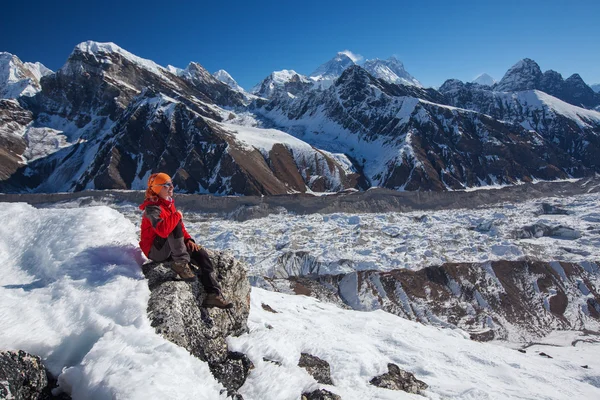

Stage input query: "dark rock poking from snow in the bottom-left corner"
[{"left": 0, "top": 350, "right": 70, "bottom": 400}]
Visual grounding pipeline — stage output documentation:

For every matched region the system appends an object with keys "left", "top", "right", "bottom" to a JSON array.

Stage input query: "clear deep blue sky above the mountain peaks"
[{"left": 0, "top": 0, "right": 600, "bottom": 89}]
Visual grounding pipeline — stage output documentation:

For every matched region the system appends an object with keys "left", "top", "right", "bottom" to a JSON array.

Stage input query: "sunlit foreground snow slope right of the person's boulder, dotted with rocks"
[{"left": 228, "top": 288, "right": 600, "bottom": 400}]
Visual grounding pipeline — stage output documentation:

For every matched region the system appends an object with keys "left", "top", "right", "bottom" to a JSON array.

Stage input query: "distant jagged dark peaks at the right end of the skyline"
[{"left": 493, "top": 58, "right": 600, "bottom": 108}]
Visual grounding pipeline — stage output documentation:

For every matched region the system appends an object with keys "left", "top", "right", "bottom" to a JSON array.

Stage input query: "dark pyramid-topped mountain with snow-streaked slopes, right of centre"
[{"left": 256, "top": 66, "right": 600, "bottom": 190}]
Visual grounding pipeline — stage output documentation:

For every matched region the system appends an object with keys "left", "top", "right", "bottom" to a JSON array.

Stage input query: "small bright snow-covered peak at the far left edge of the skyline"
[{"left": 0, "top": 52, "right": 52, "bottom": 99}]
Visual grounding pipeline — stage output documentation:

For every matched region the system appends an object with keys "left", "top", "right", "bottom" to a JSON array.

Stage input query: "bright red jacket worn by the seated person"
[{"left": 140, "top": 197, "right": 193, "bottom": 257}]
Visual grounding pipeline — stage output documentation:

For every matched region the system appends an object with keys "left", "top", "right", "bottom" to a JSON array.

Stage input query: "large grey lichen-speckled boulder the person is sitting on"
[{"left": 142, "top": 251, "right": 253, "bottom": 398}]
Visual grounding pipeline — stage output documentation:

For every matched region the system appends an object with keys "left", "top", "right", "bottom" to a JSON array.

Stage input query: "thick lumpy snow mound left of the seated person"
[{"left": 0, "top": 204, "right": 221, "bottom": 400}]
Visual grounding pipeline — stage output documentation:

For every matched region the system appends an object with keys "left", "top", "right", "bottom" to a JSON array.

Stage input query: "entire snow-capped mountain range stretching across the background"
[{"left": 0, "top": 41, "right": 600, "bottom": 195}]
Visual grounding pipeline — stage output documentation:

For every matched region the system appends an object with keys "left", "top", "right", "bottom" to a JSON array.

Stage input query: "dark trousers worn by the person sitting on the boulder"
[{"left": 148, "top": 223, "right": 221, "bottom": 294}]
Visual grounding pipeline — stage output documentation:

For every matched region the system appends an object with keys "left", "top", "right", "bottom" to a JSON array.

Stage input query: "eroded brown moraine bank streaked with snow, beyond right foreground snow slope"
[{"left": 262, "top": 260, "right": 600, "bottom": 342}]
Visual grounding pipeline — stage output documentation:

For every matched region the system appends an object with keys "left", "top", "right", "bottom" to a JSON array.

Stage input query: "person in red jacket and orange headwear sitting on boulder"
[{"left": 140, "top": 173, "right": 233, "bottom": 308}]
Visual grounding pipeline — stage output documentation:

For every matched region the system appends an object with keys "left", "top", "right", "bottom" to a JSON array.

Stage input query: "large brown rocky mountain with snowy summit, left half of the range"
[{"left": 0, "top": 42, "right": 359, "bottom": 195}]
